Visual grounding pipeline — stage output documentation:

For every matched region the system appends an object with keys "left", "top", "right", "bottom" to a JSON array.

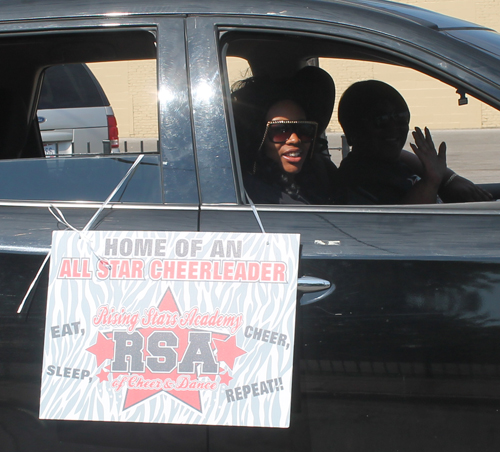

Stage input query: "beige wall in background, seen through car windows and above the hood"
[{"left": 89, "top": 0, "right": 500, "bottom": 138}]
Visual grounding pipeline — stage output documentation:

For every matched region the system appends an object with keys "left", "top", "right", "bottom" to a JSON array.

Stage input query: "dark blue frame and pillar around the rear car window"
[{"left": 0, "top": 14, "right": 199, "bottom": 207}]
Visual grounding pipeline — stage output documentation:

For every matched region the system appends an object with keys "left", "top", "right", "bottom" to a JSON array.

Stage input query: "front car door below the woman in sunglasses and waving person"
[{"left": 187, "top": 16, "right": 500, "bottom": 451}]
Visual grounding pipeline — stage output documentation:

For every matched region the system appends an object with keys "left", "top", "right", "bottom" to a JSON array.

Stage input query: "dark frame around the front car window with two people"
[{"left": 188, "top": 17, "right": 500, "bottom": 214}]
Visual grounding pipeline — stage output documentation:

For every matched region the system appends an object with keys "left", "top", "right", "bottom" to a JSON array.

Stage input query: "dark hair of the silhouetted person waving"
[{"left": 338, "top": 80, "right": 410, "bottom": 144}]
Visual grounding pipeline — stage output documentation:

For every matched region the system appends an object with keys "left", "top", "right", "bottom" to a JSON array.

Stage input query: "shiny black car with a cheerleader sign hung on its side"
[{"left": 0, "top": 0, "right": 500, "bottom": 452}]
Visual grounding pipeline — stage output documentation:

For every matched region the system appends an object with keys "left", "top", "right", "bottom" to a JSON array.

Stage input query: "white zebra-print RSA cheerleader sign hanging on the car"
[{"left": 40, "top": 231, "right": 299, "bottom": 427}]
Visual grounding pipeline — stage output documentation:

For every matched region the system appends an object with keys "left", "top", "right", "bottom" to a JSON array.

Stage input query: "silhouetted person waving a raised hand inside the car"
[{"left": 336, "top": 80, "right": 492, "bottom": 204}]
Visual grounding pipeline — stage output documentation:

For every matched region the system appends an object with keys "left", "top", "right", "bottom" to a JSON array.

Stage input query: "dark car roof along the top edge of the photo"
[{"left": 0, "top": 0, "right": 485, "bottom": 30}]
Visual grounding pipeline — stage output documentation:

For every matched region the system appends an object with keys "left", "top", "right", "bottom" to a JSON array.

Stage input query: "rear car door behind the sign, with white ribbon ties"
[{"left": 0, "top": 16, "right": 206, "bottom": 451}]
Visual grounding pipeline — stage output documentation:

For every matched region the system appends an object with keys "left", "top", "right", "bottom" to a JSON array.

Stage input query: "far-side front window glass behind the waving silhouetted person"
[{"left": 319, "top": 58, "right": 500, "bottom": 184}]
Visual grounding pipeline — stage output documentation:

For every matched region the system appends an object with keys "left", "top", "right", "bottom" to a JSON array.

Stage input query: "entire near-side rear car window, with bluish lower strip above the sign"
[{"left": 0, "top": 29, "right": 162, "bottom": 203}]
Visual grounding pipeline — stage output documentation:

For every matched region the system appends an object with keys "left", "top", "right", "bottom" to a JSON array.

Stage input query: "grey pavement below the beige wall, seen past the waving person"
[{"left": 327, "top": 129, "right": 500, "bottom": 184}]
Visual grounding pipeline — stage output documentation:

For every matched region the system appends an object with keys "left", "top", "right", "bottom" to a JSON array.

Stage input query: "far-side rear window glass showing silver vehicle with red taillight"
[{"left": 38, "top": 59, "right": 158, "bottom": 156}]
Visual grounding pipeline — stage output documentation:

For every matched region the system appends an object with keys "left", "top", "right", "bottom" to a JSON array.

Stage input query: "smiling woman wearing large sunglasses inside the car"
[{"left": 232, "top": 66, "right": 336, "bottom": 204}]
